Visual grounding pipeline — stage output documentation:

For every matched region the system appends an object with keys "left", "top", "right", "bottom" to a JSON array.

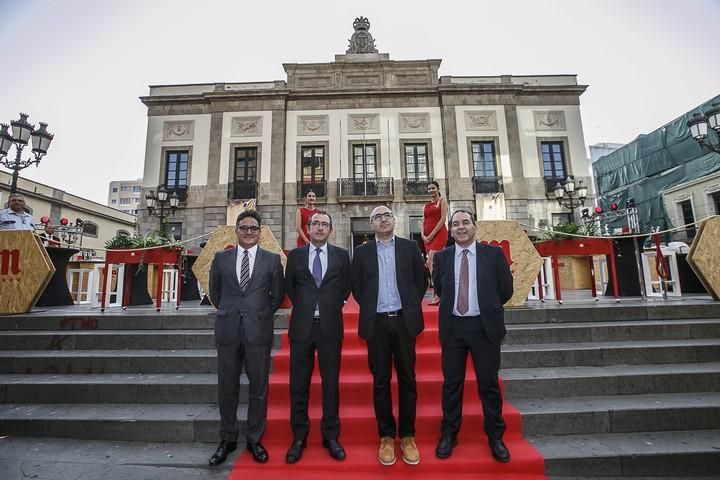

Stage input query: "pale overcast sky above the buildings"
[{"left": 0, "top": 0, "right": 720, "bottom": 203}]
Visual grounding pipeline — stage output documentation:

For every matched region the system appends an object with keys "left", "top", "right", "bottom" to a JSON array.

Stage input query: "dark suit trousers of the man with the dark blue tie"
[{"left": 290, "top": 320, "right": 342, "bottom": 441}]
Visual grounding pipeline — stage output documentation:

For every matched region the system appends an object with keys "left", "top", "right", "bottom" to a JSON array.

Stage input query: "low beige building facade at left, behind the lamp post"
[{"left": 0, "top": 171, "right": 135, "bottom": 258}]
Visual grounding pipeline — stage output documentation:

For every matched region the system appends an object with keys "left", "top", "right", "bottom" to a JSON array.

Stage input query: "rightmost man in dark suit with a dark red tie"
[{"left": 433, "top": 210, "right": 513, "bottom": 463}]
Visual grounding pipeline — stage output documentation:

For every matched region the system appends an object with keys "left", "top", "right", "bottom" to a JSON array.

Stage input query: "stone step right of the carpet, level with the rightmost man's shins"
[{"left": 512, "top": 392, "right": 720, "bottom": 435}]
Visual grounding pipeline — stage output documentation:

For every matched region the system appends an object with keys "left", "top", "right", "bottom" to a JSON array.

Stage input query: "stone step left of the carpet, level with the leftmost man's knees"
[{"left": 0, "top": 373, "right": 224, "bottom": 404}]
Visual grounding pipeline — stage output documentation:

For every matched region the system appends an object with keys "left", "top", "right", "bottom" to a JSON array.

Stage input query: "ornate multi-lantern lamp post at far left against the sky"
[{"left": 0, "top": 113, "right": 53, "bottom": 193}]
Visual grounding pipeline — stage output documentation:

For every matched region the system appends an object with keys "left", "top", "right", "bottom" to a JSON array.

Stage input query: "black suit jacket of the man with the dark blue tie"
[{"left": 285, "top": 243, "right": 351, "bottom": 342}]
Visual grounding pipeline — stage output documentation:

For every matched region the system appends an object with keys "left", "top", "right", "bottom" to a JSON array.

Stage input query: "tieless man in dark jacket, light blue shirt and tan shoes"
[{"left": 352, "top": 206, "right": 427, "bottom": 465}]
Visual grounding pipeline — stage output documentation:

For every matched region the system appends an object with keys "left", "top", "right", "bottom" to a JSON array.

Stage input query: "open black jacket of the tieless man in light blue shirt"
[{"left": 352, "top": 236, "right": 427, "bottom": 340}]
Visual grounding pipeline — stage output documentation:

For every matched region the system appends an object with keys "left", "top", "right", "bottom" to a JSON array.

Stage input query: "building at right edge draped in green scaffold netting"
[{"left": 593, "top": 95, "right": 720, "bottom": 242}]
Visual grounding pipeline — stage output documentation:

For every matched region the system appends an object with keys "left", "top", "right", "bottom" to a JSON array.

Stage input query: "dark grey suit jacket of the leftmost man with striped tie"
[{"left": 209, "top": 247, "right": 285, "bottom": 345}]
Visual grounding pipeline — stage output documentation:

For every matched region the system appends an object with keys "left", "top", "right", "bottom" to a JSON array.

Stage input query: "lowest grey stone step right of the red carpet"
[{"left": 528, "top": 429, "right": 720, "bottom": 479}]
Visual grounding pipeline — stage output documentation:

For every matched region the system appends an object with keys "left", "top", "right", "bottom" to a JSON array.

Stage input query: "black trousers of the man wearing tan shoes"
[{"left": 368, "top": 314, "right": 417, "bottom": 438}]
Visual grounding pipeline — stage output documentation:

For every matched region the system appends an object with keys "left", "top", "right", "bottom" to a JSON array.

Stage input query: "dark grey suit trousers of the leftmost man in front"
[{"left": 217, "top": 320, "right": 272, "bottom": 443}]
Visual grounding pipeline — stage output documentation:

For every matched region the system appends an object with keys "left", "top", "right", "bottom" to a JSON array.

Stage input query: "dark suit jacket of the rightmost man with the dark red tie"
[{"left": 433, "top": 242, "right": 513, "bottom": 343}]
